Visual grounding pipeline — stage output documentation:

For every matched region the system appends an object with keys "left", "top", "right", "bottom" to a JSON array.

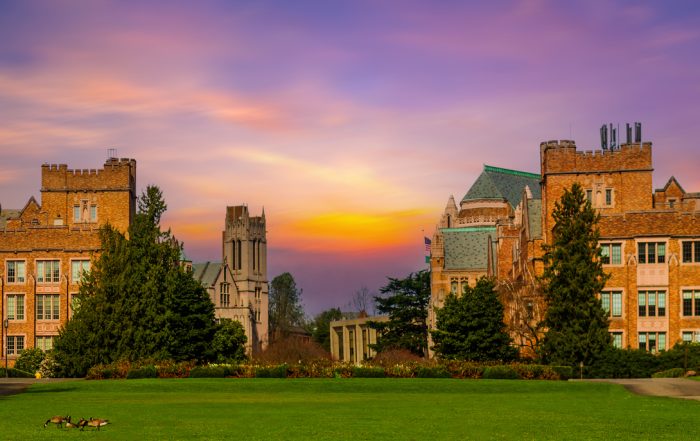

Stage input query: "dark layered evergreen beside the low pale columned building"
[{"left": 369, "top": 271, "right": 430, "bottom": 357}]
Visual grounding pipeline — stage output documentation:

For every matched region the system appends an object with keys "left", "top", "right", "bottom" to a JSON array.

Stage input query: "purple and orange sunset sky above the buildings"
[{"left": 0, "top": 0, "right": 700, "bottom": 315}]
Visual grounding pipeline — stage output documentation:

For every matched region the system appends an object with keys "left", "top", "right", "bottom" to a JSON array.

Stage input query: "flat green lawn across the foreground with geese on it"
[{"left": 0, "top": 378, "right": 700, "bottom": 441}]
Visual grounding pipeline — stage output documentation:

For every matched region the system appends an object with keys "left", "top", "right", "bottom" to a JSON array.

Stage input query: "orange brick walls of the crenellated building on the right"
[{"left": 431, "top": 140, "right": 700, "bottom": 352}]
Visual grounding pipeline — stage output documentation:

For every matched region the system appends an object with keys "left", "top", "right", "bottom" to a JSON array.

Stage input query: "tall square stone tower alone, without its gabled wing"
[{"left": 222, "top": 205, "right": 268, "bottom": 352}]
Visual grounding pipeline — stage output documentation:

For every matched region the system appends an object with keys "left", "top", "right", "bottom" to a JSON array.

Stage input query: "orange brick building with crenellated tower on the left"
[{"left": 0, "top": 158, "right": 136, "bottom": 364}]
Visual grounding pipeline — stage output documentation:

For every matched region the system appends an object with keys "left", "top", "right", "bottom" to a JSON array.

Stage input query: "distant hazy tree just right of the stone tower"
[{"left": 268, "top": 273, "right": 304, "bottom": 340}]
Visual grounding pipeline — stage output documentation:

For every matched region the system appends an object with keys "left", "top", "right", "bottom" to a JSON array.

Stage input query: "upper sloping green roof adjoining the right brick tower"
[{"left": 462, "top": 165, "right": 542, "bottom": 208}]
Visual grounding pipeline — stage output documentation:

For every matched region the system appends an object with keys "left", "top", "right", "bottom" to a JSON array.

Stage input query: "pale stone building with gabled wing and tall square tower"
[{"left": 192, "top": 205, "right": 269, "bottom": 354}]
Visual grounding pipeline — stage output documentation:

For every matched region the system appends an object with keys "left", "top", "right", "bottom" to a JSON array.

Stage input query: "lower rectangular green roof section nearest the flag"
[{"left": 440, "top": 227, "right": 496, "bottom": 271}]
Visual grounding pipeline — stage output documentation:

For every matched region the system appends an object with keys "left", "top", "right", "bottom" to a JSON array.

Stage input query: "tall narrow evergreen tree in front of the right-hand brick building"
[{"left": 539, "top": 184, "right": 612, "bottom": 366}]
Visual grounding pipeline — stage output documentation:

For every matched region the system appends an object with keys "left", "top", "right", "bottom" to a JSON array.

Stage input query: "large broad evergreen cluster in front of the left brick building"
[{"left": 54, "top": 186, "right": 215, "bottom": 376}]
